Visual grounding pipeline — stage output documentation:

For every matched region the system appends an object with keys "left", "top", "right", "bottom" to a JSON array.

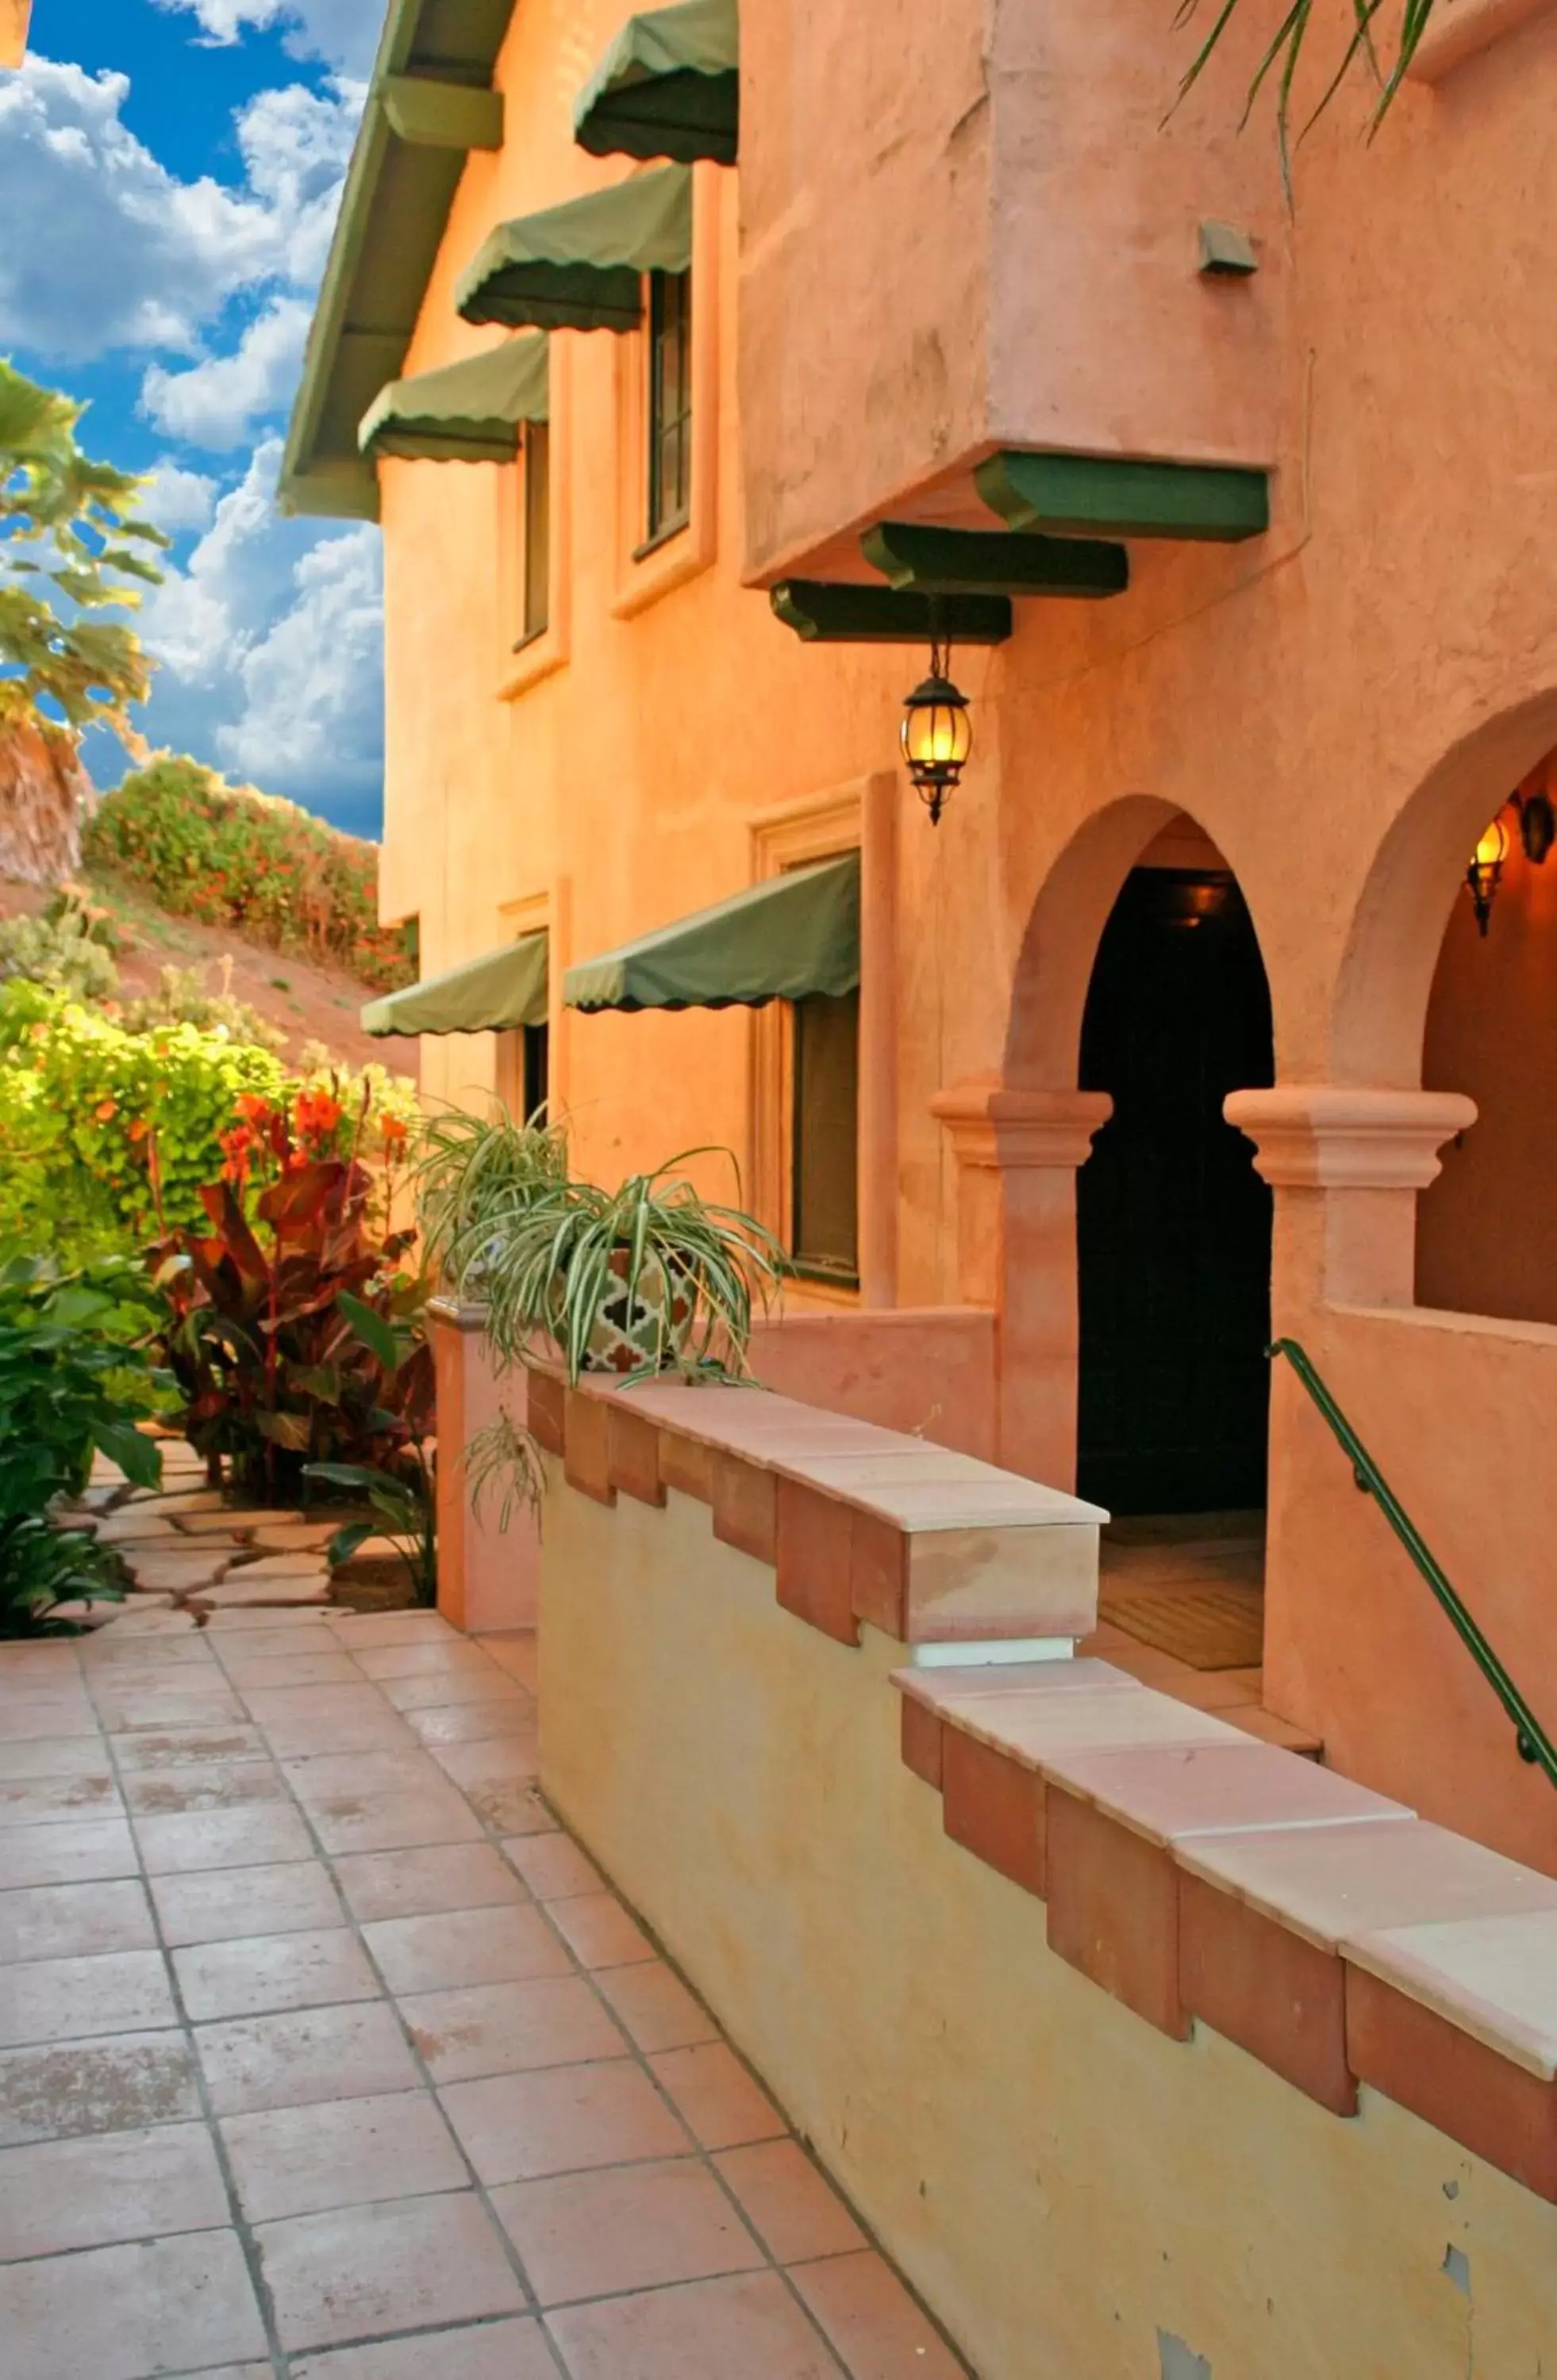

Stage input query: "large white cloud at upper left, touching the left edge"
[{"left": 0, "top": 57, "right": 362, "bottom": 362}]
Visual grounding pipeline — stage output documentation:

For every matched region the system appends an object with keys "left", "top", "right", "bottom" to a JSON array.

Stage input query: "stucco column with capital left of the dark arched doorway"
[{"left": 931, "top": 1081, "right": 1114, "bottom": 1488}]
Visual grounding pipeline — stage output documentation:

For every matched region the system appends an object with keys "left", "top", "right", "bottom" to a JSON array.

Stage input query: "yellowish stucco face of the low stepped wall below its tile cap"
[{"left": 540, "top": 1466, "right": 1557, "bottom": 2380}]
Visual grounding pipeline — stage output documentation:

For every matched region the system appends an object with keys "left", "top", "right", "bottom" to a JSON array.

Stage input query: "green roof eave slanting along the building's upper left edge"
[{"left": 279, "top": 0, "right": 514, "bottom": 521}]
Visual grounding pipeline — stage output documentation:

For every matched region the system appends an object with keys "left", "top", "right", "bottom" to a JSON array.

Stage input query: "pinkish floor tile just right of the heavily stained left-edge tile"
[{"left": 195, "top": 2002, "right": 421, "bottom": 2116}]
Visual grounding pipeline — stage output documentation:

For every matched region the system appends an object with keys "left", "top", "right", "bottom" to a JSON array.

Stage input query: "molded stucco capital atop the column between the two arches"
[{"left": 1221, "top": 1083, "right": 1476, "bottom": 1190}]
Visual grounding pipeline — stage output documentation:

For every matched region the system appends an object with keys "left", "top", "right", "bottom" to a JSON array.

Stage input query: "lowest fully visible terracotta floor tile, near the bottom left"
[{"left": 257, "top": 2192, "right": 524, "bottom": 2349}]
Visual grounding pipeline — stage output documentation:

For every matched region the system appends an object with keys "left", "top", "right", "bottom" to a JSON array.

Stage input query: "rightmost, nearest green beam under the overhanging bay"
[{"left": 974, "top": 450, "right": 1271, "bottom": 545}]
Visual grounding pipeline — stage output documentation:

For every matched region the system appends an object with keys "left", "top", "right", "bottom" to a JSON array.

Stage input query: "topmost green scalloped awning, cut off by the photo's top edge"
[{"left": 574, "top": 0, "right": 740, "bottom": 164}]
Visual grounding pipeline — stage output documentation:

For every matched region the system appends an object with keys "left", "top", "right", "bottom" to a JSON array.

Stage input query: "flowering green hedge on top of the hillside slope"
[{"left": 83, "top": 754, "right": 417, "bottom": 990}]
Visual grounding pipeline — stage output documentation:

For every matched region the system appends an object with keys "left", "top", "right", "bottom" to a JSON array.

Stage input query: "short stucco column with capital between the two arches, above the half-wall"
[{"left": 1224, "top": 1083, "right": 1476, "bottom": 1330}]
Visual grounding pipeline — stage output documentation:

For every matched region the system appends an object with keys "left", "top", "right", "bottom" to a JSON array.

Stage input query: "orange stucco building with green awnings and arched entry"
[{"left": 283, "top": 0, "right": 1557, "bottom": 1871}]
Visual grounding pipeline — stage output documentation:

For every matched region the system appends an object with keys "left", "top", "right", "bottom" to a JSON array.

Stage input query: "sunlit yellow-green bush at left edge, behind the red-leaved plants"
[{"left": 0, "top": 981, "right": 286, "bottom": 1259}]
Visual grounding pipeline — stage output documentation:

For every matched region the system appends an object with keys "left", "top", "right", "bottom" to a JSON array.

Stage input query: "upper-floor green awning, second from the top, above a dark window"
[{"left": 455, "top": 164, "right": 693, "bottom": 331}]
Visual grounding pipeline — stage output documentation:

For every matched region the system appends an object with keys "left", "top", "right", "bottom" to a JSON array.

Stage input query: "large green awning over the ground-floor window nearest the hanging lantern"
[{"left": 562, "top": 852, "right": 859, "bottom": 1009}]
